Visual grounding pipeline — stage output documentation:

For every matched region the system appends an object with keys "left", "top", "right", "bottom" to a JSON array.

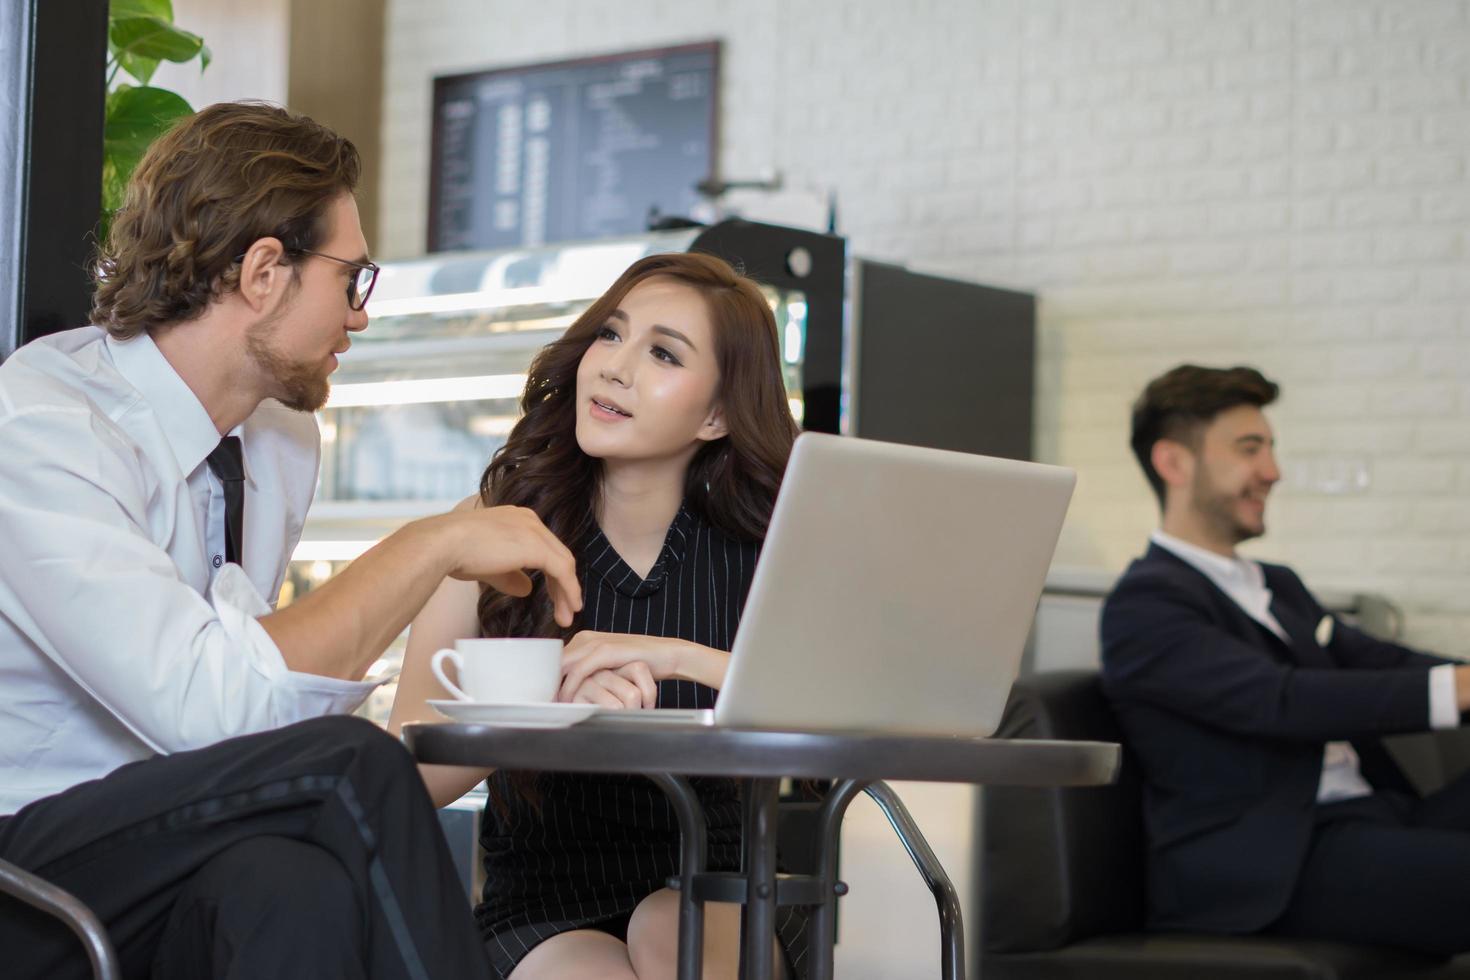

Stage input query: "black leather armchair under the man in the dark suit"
[{"left": 979, "top": 670, "right": 1470, "bottom": 980}]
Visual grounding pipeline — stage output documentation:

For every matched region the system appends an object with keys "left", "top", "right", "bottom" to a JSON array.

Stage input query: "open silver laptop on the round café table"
[{"left": 594, "top": 432, "right": 1076, "bottom": 736}]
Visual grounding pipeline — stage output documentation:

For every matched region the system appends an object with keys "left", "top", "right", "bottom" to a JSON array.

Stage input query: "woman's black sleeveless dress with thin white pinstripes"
[{"left": 475, "top": 508, "right": 807, "bottom": 977}]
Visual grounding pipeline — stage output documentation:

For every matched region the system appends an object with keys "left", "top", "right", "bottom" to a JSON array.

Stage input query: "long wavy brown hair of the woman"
[{"left": 479, "top": 253, "right": 797, "bottom": 638}]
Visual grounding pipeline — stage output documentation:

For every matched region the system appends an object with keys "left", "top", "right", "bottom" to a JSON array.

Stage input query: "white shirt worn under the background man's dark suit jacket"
[{"left": 1152, "top": 530, "right": 1460, "bottom": 804}]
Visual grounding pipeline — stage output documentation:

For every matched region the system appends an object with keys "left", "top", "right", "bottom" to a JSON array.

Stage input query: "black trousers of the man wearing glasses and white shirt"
[{"left": 0, "top": 717, "right": 490, "bottom": 980}]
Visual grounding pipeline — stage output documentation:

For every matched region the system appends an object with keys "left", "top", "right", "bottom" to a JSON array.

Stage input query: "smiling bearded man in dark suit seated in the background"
[{"left": 1103, "top": 364, "right": 1470, "bottom": 954}]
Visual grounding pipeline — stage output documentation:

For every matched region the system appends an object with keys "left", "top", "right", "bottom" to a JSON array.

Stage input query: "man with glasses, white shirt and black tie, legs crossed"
[{"left": 0, "top": 103, "right": 581, "bottom": 980}]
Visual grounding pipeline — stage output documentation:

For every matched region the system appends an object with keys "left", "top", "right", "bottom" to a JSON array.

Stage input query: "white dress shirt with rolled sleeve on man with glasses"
[{"left": 0, "top": 326, "right": 373, "bottom": 814}]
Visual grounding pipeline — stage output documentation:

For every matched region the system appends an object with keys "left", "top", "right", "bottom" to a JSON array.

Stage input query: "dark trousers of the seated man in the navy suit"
[{"left": 1270, "top": 774, "right": 1470, "bottom": 956}]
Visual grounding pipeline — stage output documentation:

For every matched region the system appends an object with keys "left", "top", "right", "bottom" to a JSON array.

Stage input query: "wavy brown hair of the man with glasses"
[{"left": 91, "top": 101, "right": 362, "bottom": 339}]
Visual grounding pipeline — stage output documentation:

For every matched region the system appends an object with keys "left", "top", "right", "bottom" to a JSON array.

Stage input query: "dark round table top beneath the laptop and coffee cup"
[{"left": 403, "top": 723, "right": 1120, "bottom": 786}]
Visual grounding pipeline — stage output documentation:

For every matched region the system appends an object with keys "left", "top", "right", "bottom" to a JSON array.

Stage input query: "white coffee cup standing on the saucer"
[{"left": 429, "top": 638, "right": 562, "bottom": 704}]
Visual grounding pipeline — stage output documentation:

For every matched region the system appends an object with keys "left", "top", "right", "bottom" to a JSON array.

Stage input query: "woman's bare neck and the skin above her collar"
[{"left": 597, "top": 460, "right": 688, "bottom": 579}]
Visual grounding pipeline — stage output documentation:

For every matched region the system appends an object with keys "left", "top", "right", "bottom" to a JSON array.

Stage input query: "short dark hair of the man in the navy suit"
[{"left": 1130, "top": 364, "right": 1280, "bottom": 507}]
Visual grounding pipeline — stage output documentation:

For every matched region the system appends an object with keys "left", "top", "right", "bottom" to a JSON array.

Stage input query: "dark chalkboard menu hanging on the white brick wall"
[{"left": 428, "top": 41, "right": 719, "bottom": 251}]
